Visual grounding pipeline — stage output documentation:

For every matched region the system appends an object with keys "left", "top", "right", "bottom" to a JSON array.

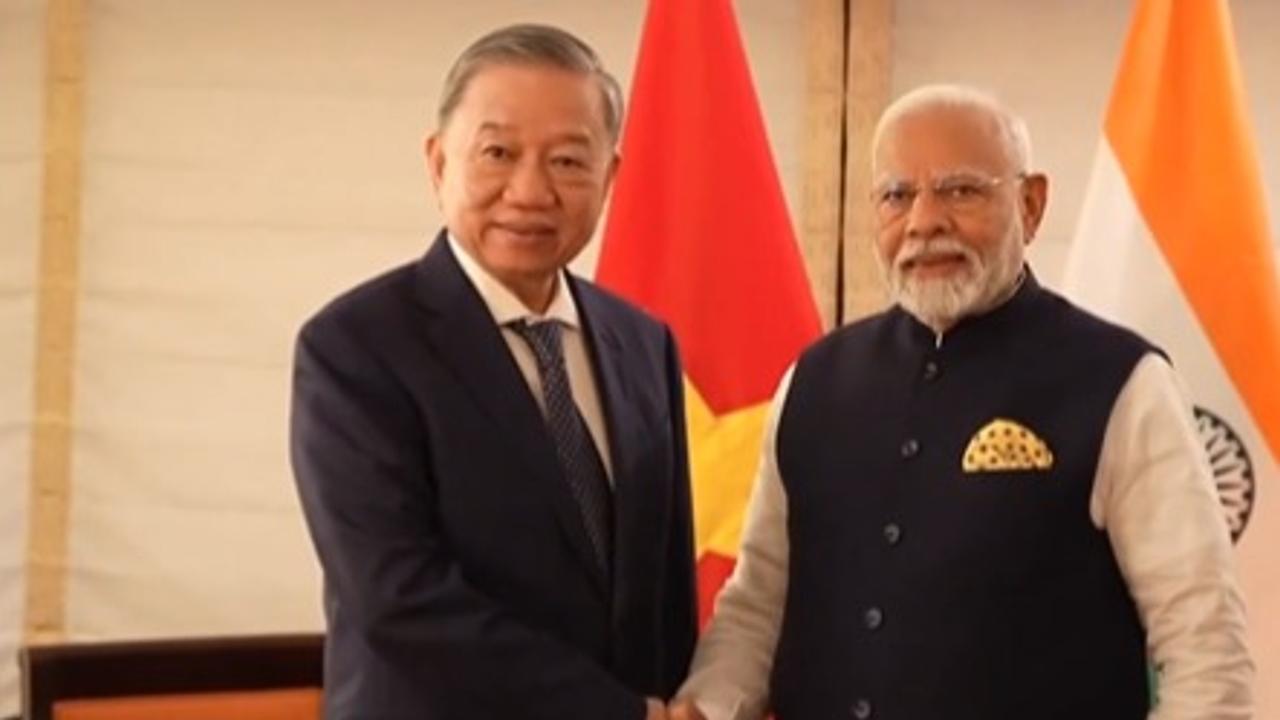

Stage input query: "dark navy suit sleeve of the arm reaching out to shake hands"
[{"left": 291, "top": 316, "right": 645, "bottom": 719}]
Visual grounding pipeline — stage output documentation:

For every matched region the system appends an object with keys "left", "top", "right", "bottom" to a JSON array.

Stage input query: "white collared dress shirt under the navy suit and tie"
[{"left": 448, "top": 233, "right": 613, "bottom": 484}]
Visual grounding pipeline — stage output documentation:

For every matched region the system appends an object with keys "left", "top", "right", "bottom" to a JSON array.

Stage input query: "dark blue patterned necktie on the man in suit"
[{"left": 508, "top": 320, "right": 613, "bottom": 578}]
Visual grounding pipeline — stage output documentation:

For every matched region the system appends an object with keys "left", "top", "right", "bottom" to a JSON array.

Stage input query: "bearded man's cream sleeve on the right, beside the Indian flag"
[{"left": 1091, "top": 354, "right": 1253, "bottom": 720}]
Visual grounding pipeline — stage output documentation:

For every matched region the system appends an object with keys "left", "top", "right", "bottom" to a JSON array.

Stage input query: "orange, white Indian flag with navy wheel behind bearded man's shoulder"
[{"left": 1065, "top": 0, "right": 1280, "bottom": 717}]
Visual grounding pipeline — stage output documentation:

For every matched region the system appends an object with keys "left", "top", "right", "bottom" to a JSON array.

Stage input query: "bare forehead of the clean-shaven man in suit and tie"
[{"left": 449, "top": 63, "right": 605, "bottom": 136}]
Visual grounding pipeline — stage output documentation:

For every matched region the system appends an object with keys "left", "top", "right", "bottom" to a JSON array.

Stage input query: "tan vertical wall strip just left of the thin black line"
[{"left": 799, "top": 0, "right": 845, "bottom": 328}]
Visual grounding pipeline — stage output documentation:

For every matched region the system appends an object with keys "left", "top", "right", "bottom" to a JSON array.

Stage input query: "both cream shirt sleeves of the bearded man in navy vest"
[{"left": 678, "top": 354, "right": 1253, "bottom": 720}]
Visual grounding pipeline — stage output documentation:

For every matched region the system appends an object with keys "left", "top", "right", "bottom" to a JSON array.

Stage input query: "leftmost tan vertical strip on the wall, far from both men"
[{"left": 26, "top": 0, "right": 84, "bottom": 642}]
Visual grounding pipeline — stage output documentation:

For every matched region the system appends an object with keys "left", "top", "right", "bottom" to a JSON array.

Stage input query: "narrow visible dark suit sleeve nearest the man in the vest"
[{"left": 662, "top": 331, "right": 698, "bottom": 698}]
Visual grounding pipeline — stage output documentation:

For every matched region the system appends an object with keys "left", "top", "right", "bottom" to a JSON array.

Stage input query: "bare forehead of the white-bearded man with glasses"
[{"left": 876, "top": 106, "right": 1010, "bottom": 177}]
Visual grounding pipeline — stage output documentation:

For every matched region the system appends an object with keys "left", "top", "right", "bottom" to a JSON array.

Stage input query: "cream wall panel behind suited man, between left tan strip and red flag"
[{"left": 60, "top": 0, "right": 803, "bottom": 638}]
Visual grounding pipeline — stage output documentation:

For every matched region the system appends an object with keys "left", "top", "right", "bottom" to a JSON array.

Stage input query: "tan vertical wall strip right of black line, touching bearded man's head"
[{"left": 842, "top": 0, "right": 893, "bottom": 322}]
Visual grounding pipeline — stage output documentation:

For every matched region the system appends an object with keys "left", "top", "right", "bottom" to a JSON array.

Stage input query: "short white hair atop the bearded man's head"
[{"left": 872, "top": 85, "right": 1032, "bottom": 174}]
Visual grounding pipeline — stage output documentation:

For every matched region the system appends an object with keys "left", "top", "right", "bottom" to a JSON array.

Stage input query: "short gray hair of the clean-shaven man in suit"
[{"left": 436, "top": 24, "right": 622, "bottom": 142}]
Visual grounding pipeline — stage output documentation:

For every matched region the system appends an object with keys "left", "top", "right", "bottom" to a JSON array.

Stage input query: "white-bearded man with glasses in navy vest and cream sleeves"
[{"left": 673, "top": 86, "right": 1253, "bottom": 720}]
